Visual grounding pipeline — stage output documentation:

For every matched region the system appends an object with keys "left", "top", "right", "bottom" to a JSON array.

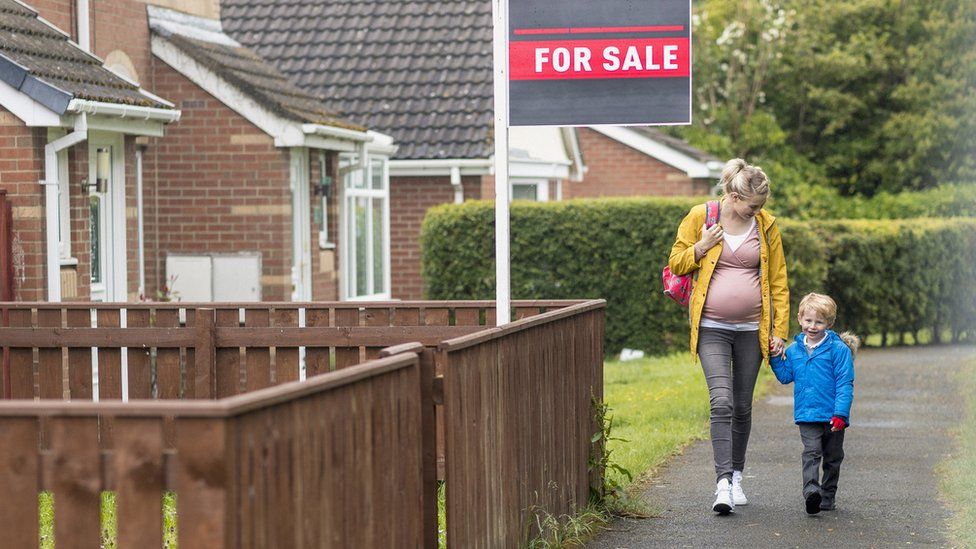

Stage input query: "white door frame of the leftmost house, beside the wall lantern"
[{"left": 88, "top": 131, "right": 129, "bottom": 301}]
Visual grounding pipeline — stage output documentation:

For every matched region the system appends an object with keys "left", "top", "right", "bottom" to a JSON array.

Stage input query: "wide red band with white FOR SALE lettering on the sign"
[{"left": 508, "top": 37, "right": 691, "bottom": 80}]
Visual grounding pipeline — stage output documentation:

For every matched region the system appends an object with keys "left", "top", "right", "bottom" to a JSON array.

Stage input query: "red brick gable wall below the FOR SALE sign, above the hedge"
[{"left": 563, "top": 128, "right": 712, "bottom": 200}]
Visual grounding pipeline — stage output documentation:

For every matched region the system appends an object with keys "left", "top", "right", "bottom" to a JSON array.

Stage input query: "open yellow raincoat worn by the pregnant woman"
[{"left": 668, "top": 204, "right": 790, "bottom": 361}]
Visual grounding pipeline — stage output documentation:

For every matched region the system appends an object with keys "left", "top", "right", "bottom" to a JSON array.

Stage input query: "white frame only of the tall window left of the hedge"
[{"left": 339, "top": 154, "right": 392, "bottom": 301}]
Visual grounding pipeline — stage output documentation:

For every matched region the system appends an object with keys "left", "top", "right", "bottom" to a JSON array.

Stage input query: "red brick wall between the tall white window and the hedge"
[{"left": 390, "top": 176, "right": 482, "bottom": 299}]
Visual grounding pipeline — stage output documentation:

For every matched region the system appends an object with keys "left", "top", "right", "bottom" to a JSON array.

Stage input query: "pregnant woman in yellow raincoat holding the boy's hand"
[{"left": 668, "top": 158, "right": 790, "bottom": 515}]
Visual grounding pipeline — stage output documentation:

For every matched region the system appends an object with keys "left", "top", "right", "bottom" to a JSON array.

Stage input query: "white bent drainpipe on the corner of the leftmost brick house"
[{"left": 40, "top": 113, "right": 88, "bottom": 301}]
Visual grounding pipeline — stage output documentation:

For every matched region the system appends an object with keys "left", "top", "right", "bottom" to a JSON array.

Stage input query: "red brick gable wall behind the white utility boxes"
[{"left": 145, "top": 60, "right": 292, "bottom": 301}]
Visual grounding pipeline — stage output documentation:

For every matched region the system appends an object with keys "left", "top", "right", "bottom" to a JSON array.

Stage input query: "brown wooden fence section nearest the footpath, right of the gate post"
[{"left": 438, "top": 301, "right": 604, "bottom": 548}]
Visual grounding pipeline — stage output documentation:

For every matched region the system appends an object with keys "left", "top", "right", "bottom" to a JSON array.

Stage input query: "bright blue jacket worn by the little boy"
[{"left": 769, "top": 330, "right": 854, "bottom": 423}]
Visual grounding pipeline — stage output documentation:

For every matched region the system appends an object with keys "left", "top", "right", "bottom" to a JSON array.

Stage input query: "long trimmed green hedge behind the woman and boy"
[{"left": 421, "top": 198, "right": 976, "bottom": 353}]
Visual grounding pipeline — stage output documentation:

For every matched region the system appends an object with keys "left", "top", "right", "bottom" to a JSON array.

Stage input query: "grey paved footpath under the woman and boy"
[{"left": 587, "top": 346, "right": 976, "bottom": 549}]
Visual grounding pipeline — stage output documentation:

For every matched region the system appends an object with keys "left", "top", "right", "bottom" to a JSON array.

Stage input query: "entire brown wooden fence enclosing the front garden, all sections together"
[{"left": 0, "top": 301, "right": 604, "bottom": 549}]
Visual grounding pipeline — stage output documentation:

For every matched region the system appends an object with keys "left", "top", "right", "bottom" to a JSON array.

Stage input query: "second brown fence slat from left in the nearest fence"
[{"left": 50, "top": 417, "right": 102, "bottom": 549}]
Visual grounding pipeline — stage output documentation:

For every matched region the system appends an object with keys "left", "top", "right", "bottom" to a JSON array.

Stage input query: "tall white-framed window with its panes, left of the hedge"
[{"left": 340, "top": 156, "right": 390, "bottom": 299}]
